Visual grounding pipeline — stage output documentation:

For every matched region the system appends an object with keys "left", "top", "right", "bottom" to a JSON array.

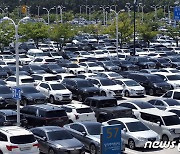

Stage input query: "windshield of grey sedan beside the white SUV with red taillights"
[{"left": 47, "top": 130, "right": 73, "bottom": 141}]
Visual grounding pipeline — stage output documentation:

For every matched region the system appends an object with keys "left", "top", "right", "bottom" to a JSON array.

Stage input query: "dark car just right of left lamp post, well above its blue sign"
[{"left": 22, "top": 65, "right": 46, "bottom": 74}]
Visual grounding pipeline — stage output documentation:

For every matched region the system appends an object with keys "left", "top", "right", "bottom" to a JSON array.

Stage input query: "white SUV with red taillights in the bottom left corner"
[{"left": 0, "top": 126, "right": 39, "bottom": 154}]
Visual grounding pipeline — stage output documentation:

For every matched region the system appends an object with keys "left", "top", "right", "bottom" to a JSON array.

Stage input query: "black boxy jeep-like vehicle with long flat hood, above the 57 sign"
[{"left": 83, "top": 96, "right": 133, "bottom": 122}]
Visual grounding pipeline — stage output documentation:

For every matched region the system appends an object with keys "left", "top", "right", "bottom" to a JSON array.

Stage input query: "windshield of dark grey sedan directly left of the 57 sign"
[{"left": 86, "top": 123, "right": 102, "bottom": 135}]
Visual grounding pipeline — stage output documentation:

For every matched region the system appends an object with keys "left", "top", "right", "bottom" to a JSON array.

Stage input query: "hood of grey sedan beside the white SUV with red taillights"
[{"left": 49, "top": 138, "right": 83, "bottom": 148}]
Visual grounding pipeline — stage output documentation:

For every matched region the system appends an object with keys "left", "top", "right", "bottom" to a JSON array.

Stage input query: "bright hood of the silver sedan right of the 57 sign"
[{"left": 129, "top": 130, "right": 158, "bottom": 138}]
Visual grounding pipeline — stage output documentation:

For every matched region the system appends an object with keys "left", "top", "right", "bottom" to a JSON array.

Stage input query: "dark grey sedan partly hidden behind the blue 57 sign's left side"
[{"left": 64, "top": 122, "right": 125, "bottom": 154}]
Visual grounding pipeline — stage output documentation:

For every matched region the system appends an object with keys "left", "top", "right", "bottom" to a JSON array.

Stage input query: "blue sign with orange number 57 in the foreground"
[{"left": 101, "top": 125, "right": 121, "bottom": 154}]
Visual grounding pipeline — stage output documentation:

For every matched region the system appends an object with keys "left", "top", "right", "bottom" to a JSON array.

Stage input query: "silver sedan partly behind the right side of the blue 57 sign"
[{"left": 103, "top": 118, "right": 160, "bottom": 149}]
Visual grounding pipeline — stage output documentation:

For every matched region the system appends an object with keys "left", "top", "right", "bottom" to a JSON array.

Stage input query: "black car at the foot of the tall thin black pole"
[{"left": 127, "top": 56, "right": 156, "bottom": 69}]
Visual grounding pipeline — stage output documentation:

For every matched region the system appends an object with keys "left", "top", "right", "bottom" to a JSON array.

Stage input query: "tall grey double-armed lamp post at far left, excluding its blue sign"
[{"left": 3, "top": 17, "right": 29, "bottom": 126}]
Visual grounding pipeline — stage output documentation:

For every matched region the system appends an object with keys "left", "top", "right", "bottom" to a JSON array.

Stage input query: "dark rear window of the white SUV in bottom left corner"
[{"left": 10, "top": 135, "right": 36, "bottom": 144}]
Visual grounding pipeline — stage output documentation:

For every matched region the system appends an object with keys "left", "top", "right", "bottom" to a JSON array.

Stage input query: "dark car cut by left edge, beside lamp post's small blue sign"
[{"left": 0, "top": 85, "right": 16, "bottom": 109}]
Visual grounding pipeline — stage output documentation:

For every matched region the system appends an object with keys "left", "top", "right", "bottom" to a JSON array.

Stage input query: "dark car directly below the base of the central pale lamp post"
[{"left": 96, "top": 61, "right": 120, "bottom": 72}]
